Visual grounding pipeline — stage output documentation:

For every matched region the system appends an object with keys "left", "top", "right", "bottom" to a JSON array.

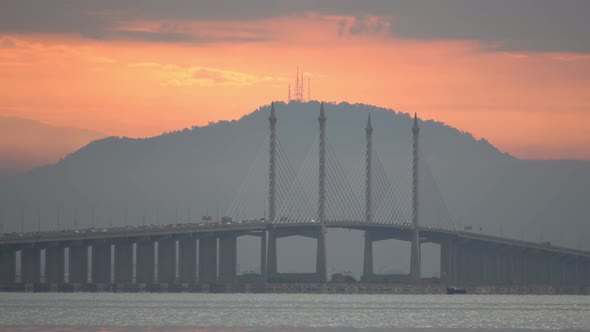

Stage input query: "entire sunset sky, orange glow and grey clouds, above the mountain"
[{"left": 0, "top": 0, "right": 590, "bottom": 159}]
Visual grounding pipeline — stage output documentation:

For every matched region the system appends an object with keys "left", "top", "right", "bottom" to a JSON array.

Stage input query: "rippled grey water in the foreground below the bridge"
[{"left": 0, "top": 293, "right": 590, "bottom": 332}]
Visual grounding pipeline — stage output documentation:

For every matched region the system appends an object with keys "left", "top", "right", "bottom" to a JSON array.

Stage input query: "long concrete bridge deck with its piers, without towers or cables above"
[{"left": 0, "top": 220, "right": 590, "bottom": 290}]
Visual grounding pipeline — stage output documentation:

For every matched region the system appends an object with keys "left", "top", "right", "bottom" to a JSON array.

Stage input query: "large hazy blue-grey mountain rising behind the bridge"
[{"left": 0, "top": 102, "right": 590, "bottom": 276}]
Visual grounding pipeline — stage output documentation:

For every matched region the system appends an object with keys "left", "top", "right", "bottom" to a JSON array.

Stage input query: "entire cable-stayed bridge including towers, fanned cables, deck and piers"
[{"left": 0, "top": 104, "right": 590, "bottom": 289}]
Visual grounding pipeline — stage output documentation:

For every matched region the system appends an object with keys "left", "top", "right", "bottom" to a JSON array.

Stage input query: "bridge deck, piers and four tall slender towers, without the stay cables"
[{"left": 0, "top": 104, "right": 590, "bottom": 293}]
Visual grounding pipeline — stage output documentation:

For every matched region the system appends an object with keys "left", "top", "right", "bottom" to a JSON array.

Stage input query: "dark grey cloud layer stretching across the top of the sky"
[{"left": 0, "top": 0, "right": 590, "bottom": 53}]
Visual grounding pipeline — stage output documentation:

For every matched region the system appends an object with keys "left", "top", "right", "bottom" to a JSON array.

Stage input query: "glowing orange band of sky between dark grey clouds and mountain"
[{"left": 0, "top": 13, "right": 590, "bottom": 159}]
